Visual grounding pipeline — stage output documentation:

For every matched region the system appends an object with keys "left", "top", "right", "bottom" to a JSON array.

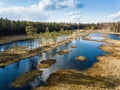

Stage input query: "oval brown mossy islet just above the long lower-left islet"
[{"left": 38, "top": 59, "right": 56, "bottom": 68}]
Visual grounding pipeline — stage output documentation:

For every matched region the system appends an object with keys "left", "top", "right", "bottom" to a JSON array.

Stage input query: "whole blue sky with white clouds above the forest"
[{"left": 0, "top": 0, "right": 120, "bottom": 23}]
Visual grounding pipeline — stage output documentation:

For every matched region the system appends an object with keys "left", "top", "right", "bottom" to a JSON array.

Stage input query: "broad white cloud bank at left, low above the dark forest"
[{"left": 0, "top": 1, "right": 48, "bottom": 21}]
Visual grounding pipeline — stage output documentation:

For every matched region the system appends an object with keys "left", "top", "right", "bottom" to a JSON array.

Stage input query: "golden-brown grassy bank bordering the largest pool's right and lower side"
[{"left": 33, "top": 31, "right": 120, "bottom": 90}]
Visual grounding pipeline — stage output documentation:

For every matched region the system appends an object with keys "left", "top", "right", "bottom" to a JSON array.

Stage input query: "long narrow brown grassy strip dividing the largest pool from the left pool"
[{"left": 0, "top": 32, "right": 89, "bottom": 67}]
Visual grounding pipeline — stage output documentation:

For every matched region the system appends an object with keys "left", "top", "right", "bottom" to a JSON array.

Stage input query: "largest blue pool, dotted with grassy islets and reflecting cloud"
[{"left": 0, "top": 32, "right": 117, "bottom": 90}]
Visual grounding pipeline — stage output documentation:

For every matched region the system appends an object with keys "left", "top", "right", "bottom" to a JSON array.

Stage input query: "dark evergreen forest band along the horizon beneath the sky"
[{"left": 0, "top": 18, "right": 120, "bottom": 36}]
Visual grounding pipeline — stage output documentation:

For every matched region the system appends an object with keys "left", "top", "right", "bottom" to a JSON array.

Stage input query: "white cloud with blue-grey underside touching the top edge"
[{"left": 38, "top": 0, "right": 84, "bottom": 10}]
